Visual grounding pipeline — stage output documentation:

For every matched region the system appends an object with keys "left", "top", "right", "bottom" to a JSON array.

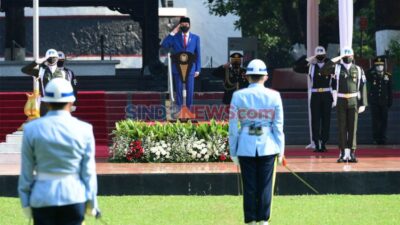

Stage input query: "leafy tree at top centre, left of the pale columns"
[{"left": 206, "top": 0, "right": 293, "bottom": 67}]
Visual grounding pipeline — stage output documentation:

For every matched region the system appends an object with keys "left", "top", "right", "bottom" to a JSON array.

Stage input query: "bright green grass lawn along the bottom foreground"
[{"left": 0, "top": 195, "right": 400, "bottom": 225}]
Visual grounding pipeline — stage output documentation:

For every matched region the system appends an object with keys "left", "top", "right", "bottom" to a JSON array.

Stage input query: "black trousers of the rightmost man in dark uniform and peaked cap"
[{"left": 370, "top": 104, "right": 388, "bottom": 144}]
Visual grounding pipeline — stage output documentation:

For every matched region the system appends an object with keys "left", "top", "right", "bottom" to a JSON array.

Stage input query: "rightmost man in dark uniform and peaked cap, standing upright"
[{"left": 367, "top": 57, "right": 393, "bottom": 145}]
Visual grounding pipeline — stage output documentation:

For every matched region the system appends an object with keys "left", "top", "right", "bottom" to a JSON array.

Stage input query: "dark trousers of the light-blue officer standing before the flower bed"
[{"left": 239, "top": 155, "right": 276, "bottom": 223}]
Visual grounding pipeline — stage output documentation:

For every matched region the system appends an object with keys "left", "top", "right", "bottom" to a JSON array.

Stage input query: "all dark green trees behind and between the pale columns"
[{"left": 204, "top": 0, "right": 375, "bottom": 65}]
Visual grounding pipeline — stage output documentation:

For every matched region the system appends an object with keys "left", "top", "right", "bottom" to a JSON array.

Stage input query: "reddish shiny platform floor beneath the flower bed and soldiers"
[{"left": 0, "top": 145, "right": 400, "bottom": 175}]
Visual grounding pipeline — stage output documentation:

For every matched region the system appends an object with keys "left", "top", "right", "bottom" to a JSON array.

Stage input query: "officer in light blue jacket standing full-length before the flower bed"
[{"left": 229, "top": 59, "right": 285, "bottom": 225}]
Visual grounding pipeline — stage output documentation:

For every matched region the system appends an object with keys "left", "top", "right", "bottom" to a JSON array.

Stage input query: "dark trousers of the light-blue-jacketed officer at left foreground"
[{"left": 32, "top": 203, "right": 85, "bottom": 225}]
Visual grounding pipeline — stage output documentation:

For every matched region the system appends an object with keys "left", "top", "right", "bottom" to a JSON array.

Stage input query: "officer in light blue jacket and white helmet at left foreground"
[{"left": 18, "top": 78, "right": 99, "bottom": 225}]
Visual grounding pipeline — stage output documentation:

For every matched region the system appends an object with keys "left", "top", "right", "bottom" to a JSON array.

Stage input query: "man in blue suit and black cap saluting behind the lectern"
[{"left": 161, "top": 17, "right": 201, "bottom": 111}]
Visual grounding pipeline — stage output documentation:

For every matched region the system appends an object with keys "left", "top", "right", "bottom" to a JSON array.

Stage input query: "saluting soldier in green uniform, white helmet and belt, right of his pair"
[{"left": 335, "top": 47, "right": 368, "bottom": 163}]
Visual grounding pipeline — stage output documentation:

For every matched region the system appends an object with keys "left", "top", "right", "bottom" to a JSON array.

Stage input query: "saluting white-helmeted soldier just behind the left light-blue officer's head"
[{"left": 21, "top": 49, "right": 68, "bottom": 116}]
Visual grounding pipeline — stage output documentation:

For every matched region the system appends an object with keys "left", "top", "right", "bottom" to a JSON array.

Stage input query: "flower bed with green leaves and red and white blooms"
[{"left": 110, "top": 120, "right": 229, "bottom": 162}]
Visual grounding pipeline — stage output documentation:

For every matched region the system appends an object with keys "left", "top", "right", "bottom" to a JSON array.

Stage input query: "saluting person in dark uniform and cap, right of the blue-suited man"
[{"left": 212, "top": 52, "right": 249, "bottom": 105}]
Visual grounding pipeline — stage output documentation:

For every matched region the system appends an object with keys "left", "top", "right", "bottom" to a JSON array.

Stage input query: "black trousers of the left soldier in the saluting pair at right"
[{"left": 310, "top": 92, "right": 333, "bottom": 145}]
